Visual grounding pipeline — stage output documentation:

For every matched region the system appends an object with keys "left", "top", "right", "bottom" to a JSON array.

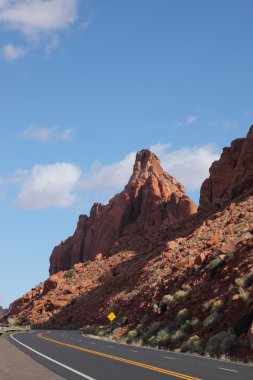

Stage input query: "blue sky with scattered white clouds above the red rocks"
[{"left": 0, "top": 0, "right": 253, "bottom": 306}]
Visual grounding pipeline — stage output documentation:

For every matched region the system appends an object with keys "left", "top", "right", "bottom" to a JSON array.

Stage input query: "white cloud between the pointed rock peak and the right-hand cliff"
[{"left": 151, "top": 144, "right": 220, "bottom": 190}]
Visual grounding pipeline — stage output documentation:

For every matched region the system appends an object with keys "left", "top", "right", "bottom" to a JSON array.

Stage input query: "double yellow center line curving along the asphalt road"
[{"left": 37, "top": 333, "right": 201, "bottom": 380}]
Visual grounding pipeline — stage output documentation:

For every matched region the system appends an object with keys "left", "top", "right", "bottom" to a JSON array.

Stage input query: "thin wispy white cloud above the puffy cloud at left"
[{"left": 21, "top": 124, "right": 74, "bottom": 144}]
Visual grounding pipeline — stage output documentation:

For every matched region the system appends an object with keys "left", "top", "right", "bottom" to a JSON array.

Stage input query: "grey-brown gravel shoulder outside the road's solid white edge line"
[{"left": 0, "top": 338, "right": 63, "bottom": 380}]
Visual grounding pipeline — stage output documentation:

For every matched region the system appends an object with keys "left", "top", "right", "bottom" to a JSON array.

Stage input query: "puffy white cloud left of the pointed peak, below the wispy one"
[{"left": 15, "top": 163, "right": 81, "bottom": 209}]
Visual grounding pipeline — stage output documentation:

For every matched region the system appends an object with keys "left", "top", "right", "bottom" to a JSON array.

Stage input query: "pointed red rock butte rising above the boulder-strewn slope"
[{"left": 50, "top": 149, "right": 197, "bottom": 274}]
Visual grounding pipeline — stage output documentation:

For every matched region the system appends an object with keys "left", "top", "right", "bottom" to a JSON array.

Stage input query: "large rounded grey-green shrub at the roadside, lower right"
[{"left": 206, "top": 331, "right": 236, "bottom": 356}]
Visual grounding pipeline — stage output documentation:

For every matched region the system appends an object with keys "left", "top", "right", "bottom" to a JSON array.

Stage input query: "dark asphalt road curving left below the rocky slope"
[{"left": 10, "top": 330, "right": 253, "bottom": 380}]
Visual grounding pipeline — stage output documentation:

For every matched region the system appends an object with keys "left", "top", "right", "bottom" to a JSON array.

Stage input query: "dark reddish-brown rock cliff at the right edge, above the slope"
[{"left": 199, "top": 125, "right": 253, "bottom": 208}]
